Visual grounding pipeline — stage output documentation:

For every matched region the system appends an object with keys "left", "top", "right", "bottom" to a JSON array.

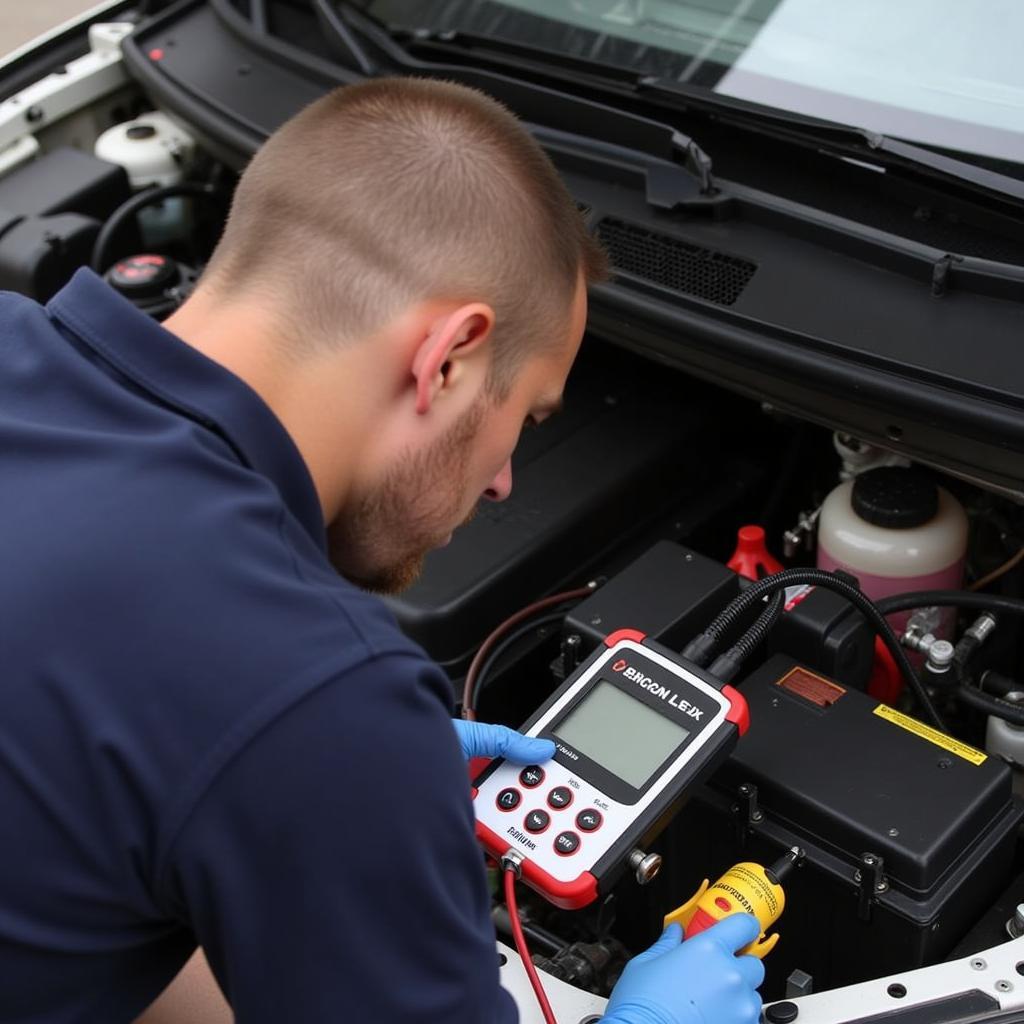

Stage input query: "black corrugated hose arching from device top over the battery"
[{"left": 683, "top": 569, "right": 945, "bottom": 731}]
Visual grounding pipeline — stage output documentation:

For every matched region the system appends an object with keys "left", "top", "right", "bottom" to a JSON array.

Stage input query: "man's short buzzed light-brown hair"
[{"left": 207, "top": 78, "right": 605, "bottom": 393}]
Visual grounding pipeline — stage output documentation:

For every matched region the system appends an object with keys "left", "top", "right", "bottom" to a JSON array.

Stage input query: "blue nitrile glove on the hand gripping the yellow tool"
[{"left": 601, "top": 913, "right": 765, "bottom": 1024}]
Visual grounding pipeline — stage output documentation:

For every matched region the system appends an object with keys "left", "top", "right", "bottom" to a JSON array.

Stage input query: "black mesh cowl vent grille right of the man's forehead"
[{"left": 597, "top": 217, "right": 758, "bottom": 306}]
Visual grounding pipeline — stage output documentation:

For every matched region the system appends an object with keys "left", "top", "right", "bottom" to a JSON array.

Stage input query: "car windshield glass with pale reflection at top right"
[{"left": 365, "top": 0, "right": 1024, "bottom": 163}]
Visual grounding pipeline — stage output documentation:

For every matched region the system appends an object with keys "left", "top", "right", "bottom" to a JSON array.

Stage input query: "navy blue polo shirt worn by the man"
[{"left": 0, "top": 270, "right": 515, "bottom": 1024}]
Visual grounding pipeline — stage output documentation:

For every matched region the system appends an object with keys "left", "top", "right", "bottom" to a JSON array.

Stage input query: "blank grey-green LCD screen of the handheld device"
[{"left": 553, "top": 679, "right": 690, "bottom": 790}]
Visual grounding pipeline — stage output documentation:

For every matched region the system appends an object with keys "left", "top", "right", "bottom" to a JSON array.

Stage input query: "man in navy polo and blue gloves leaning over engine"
[{"left": 0, "top": 79, "right": 762, "bottom": 1024}]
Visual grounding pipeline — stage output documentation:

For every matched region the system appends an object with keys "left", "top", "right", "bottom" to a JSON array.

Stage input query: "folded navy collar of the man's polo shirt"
[{"left": 46, "top": 267, "right": 326, "bottom": 551}]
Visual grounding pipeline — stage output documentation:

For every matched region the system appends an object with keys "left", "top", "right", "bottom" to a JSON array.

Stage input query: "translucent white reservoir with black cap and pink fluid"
[{"left": 818, "top": 466, "right": 968, "bottom": 635}]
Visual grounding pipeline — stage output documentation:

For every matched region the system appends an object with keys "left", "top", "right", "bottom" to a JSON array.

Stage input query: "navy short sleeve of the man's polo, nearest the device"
[{"left": 160, "top": 654, "right": 517, "bottom": 1024}]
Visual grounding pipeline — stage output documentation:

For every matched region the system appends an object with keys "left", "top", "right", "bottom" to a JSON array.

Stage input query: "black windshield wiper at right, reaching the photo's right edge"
[{"left": 636, "top": 77, "right": 1024, "bottom": 211}]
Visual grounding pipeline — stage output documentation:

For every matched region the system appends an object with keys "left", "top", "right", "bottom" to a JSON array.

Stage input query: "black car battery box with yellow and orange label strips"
[{"left": 658, "top": 655, "right": 1024, "bottom": 999}]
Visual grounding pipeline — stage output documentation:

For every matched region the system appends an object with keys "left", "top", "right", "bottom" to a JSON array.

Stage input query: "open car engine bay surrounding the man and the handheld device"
[{"left": 0, "top": 6, "right": 1024, "bottom": 1024}]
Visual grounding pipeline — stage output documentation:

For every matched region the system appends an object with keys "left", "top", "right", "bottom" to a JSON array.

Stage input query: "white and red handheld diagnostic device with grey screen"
[{"left": 473, "top": 630, "right": 749, "bottom": 909}]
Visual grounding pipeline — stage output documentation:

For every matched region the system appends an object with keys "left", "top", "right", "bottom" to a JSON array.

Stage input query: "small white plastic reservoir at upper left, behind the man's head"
[{"left": 93, "top": 111, "right": 196, "bottom": 188}]
